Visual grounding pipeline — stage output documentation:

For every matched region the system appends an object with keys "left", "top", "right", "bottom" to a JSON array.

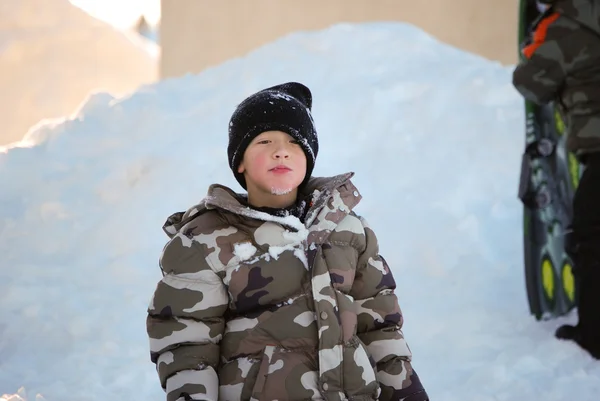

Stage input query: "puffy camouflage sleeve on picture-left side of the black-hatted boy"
[{"left": 146, "top": 233, "right": 228, "bottom": 401}]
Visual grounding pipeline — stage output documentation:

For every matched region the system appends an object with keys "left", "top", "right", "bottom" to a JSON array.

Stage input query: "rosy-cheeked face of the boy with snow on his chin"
[{"left": 238, "top": 131, "right": 306, "bottom": 207}]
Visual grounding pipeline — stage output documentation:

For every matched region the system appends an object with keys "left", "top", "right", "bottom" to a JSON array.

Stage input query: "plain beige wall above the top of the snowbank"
[{"left": 160, "top": 0, "right": 518, "bottom": 77}]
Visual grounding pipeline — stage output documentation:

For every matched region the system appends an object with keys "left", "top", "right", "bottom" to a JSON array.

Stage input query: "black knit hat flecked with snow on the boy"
[{"left": 227, "top": 82, "right": 319, "bottom": 189}]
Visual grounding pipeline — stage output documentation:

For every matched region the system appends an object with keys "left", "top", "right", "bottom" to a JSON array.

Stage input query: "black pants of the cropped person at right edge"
[{"left": 572, "top": 153, "right": 600, "bottom": 358}]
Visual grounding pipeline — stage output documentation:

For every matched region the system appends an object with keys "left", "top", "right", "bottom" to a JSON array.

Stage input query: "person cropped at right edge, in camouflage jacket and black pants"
[{"left": 513, "top": 0, "right": 600, "bottom": 359}]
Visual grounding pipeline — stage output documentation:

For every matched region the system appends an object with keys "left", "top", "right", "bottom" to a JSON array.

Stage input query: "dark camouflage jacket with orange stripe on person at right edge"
[{"left": 513, "top": 0, "right": 600, "bottom": 155}]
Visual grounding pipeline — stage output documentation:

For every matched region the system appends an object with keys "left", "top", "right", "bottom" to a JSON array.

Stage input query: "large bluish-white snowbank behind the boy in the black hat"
[{"left": 0, "top": 23, "right": 600, "bottom": 401}]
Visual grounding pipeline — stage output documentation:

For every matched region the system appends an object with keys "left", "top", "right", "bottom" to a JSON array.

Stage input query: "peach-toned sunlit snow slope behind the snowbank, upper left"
[{"left": 0, "top": 0, "right": 158, "bottom": 146}]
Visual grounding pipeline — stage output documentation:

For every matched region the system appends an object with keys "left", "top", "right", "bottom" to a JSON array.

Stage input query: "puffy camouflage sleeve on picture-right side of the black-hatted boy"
[{"left": 350, "top": 217, "right": 428, "bottom": 401}]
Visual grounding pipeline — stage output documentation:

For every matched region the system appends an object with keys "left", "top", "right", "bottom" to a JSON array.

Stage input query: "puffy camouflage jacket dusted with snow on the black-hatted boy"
[{"left": 147, "top": 173, "right": 427, "bottom": 401}]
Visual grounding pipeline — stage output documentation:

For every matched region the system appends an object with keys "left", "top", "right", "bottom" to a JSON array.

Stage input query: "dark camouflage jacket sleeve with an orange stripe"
[{"left": 513, "top": 13, "right": 589, "bottom": 104}]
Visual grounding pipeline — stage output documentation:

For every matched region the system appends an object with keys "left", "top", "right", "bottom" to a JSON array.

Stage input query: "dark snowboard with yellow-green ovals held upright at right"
[{"left": 519, "top": 0, "right": 581, "bottom": 320}]
